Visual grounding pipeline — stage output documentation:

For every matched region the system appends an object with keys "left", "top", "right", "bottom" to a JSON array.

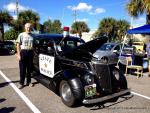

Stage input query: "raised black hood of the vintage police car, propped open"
[{"left": 63, "top": 37, "right": 108, "bottom": 61}]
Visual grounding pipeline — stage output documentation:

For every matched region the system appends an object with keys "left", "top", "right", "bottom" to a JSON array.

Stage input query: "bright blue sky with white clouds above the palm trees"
[{"left": 0, "top": 0, "right": 146, "bottom": 30}]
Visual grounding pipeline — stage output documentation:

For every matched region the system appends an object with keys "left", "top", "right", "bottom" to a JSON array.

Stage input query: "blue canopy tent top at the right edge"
[{"left": 127, "top": 24, "right": 150, "bottom": 34}]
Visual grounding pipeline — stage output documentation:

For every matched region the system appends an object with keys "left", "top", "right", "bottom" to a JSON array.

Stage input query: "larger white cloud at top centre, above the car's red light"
[{"left": 67, "top": 3, "right": 92, "bottom": 11}]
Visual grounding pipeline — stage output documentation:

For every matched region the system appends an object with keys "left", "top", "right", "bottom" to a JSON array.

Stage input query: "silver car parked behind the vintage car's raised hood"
[{"left": 93, "top": 42, "right": 122, "bottom": 64}]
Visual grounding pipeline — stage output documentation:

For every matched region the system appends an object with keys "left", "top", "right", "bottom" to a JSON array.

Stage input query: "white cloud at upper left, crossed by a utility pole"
[{"left": 4, "top": 3, "right": 29, "bottom": 12}]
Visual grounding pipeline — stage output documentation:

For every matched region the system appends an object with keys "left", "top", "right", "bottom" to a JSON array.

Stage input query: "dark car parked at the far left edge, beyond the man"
[{"left": 0, "top": 41, "right": 16, "bottom": 55}]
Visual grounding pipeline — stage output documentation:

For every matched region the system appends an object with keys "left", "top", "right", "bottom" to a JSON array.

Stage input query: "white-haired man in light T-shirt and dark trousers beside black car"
[{"left": 16, "top": 23, "right": 33, "bottom": 89}]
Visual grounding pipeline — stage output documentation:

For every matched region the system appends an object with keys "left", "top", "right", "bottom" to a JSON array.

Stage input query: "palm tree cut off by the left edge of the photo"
[{"left": 0, "top": 10, "right": 12, "bottom": 41}]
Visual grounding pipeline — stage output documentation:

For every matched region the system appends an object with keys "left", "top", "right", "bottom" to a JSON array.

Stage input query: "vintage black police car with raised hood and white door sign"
[{"left": 33, "top": 34, "right": 130, "bottom": 107}]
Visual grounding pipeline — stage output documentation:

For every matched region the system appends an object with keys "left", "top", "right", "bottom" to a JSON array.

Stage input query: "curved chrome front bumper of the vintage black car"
[{"left": 83, "top": 89, "right": 131, "bottom": 104}]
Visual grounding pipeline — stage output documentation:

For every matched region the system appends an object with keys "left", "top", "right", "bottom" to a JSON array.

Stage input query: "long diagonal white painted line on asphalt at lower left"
[{"left": 0, "top": 70, "right": 41, "bottom": 113}]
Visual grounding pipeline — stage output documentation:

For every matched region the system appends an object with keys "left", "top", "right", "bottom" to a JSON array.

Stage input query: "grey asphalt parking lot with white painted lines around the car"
[{"left": 0, "top": 55, "right": 150, "bottom": 113}]
